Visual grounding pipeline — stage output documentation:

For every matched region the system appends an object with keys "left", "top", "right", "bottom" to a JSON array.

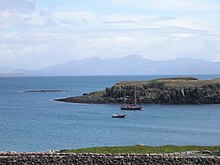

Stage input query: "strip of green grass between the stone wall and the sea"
[{"left": 61, "top": 145, "right": 220, "bottom": 154}]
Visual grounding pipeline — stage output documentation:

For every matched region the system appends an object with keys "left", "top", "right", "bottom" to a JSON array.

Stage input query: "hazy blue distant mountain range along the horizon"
[{"left": 2, "top": 55, "right": 220, "bottom": 76}]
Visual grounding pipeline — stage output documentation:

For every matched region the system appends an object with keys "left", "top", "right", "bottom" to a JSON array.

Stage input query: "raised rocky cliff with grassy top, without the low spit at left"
[{"left": 104, "top": 78, "right": 220, "bottom": 104}]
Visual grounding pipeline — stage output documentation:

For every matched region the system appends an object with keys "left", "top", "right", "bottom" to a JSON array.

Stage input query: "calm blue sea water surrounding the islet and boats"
[{"left": 0, "top": 75, "right": 220, "bottom": 151}]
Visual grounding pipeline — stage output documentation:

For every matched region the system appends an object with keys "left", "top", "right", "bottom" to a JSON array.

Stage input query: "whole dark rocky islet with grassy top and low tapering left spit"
[{"left": 56, "top": 77, "right": 220, "bottom": 104}]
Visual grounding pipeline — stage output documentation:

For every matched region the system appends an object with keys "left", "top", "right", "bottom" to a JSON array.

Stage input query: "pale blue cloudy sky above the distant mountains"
[{"left": 0, "top": 0, "right": 220, "bottom": 72}]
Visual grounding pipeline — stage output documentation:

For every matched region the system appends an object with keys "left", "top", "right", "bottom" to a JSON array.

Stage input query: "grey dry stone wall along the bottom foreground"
[{"left": 0, "top": 152, "right": 220, "bottom": 165}]
